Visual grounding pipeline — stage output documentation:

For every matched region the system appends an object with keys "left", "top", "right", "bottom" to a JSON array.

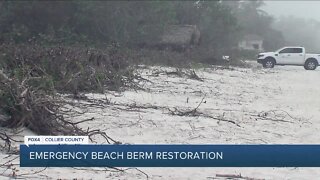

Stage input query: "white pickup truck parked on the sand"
[{"left": 257, "top": 47, "right": 320, "bottom": 70}]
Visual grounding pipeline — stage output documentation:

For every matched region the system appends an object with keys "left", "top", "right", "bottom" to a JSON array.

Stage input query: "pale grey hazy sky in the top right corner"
[{"left": 261, "top": 0, "right": 320, "bottom": 21}]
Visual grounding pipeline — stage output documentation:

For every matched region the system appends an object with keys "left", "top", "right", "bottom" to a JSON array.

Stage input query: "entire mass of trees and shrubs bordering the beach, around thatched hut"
[{"left": 0, "top": 0, "right": 281, "bottom": 134}]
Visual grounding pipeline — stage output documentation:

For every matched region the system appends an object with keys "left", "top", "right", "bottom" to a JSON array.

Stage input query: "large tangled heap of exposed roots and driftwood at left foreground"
[{"left": 0, "top": 71, "right": 120, "bottom": 147}]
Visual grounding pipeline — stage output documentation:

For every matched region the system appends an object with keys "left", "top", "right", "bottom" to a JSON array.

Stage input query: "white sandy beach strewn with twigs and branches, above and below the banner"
[{"left": 0, "top": 63, "right": 320, "bottom": 180}]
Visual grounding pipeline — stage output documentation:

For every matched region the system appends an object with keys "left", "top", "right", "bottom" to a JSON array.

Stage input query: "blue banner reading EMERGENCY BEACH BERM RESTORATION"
[{"left": 20, "top": 145, "right": 320, "bottom": 167}]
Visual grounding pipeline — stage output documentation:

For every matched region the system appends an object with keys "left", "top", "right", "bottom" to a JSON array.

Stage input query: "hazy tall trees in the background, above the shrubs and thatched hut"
[{"left": 0, "top": 0, "right": 283, "bottom": 49}]
